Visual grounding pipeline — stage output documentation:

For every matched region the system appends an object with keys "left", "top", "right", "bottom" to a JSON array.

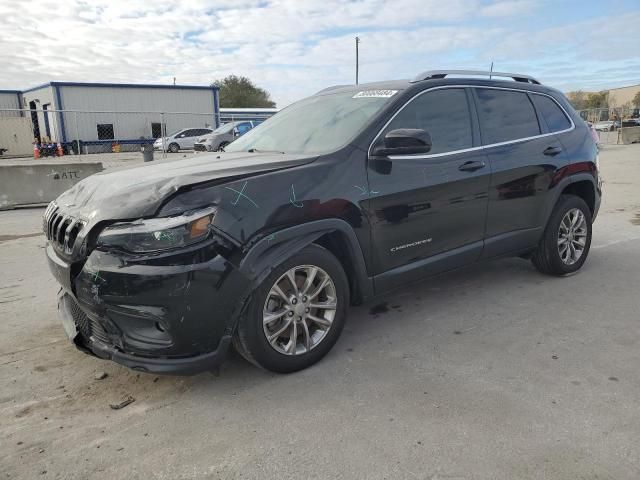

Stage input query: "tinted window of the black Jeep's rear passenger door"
[{"left": 475, "top": 88, "right": 540, "bottom": 145}]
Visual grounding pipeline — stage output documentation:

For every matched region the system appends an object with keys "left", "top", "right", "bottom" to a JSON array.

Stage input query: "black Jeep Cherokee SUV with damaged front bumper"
[{"left": 44, "top": 71, "right": 601, "bottom": 374}]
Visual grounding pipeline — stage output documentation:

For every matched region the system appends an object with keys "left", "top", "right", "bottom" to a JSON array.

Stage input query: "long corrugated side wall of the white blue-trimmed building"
[{"left": 58, "top": 85, "right": 215, "bottom": 142}]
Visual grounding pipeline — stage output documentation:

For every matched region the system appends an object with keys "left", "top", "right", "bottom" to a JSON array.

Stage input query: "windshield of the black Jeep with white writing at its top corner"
[{"left": 225, "top": 90, "right": 397, "bottom": 153}]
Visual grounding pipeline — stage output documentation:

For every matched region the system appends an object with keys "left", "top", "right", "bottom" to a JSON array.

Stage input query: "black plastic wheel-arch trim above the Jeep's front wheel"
[{"left": 239, "top": 219, "right": 373, "bottom": 303}]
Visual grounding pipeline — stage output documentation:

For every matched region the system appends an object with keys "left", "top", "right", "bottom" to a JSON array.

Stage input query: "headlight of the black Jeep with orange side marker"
[{"left": 97, "top": 208, "right": 215, "bottom": 253}]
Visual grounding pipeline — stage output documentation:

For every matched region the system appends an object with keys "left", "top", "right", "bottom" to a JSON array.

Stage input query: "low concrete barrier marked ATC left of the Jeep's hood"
[{"left": 0, "top": 161, "right": 102, "bottom": 210}]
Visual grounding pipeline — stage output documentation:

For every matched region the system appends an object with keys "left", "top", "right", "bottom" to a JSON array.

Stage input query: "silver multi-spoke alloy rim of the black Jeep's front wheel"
[{"left": 262, "top": 265, "right": 338, "bottom": 355}]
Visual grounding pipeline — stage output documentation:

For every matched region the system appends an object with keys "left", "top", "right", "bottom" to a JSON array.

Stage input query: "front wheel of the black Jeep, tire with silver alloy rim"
[{"left": 233, "top": 245, "right": 349, "bottom": 373}]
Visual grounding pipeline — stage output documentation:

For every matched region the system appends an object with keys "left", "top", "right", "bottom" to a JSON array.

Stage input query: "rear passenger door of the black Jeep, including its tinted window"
[{"left": 473, "top": 87, "right": 568, "bottom": 257}]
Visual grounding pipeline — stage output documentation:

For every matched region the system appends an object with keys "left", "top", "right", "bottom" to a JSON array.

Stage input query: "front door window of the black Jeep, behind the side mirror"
[{"left": 382, "top": 88, "right": 473, "bottom": 154}]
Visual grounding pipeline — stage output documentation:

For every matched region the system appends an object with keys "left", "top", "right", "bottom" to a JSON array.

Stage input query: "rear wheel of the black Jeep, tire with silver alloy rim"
[{"left": 531, "top": 195, "right": 592, "bottom": 276}]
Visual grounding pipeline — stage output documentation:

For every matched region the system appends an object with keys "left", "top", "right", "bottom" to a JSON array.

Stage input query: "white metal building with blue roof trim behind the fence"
[{"left": 20, "top": 82, "right": 220, "bottom": 147}]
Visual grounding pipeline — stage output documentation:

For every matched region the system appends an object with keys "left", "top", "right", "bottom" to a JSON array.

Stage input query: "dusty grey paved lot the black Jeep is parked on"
[{"left": 0, "top": 145, "right": 640, "bottom": 480}]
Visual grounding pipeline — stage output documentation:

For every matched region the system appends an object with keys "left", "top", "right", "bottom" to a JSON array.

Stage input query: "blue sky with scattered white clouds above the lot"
[{"left": 0, "top": 0, "right": 640, "bottom": 107}]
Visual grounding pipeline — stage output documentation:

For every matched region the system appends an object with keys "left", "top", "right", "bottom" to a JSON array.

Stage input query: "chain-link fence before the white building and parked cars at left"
[{"left": 0, "top": 109, "right": 272, "bottom": 160}]
